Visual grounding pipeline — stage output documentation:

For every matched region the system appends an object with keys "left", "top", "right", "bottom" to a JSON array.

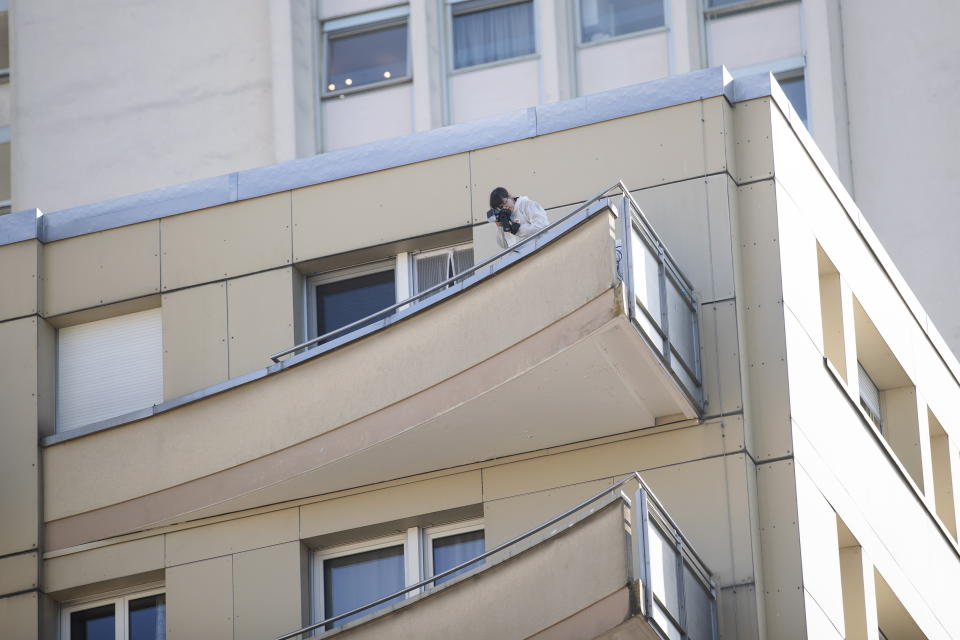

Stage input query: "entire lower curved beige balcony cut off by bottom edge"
[{"left": 278, "top": 473, "right": 718, "bottom": 640}]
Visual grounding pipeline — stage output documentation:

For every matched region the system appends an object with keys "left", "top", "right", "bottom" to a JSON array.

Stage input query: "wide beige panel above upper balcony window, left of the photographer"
[{"left": 293, "top": 154, "right": 472, "bottom": 262}]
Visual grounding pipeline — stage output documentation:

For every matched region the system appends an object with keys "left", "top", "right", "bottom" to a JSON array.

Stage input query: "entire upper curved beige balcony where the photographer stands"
[{"left": 44, "top": 184, "right": 702, "bottom": 549}]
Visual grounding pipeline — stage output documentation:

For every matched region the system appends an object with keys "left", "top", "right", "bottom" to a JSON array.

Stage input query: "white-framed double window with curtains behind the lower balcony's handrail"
[{"left": 312, "top": 521, "right": 484, "bottom": 629}]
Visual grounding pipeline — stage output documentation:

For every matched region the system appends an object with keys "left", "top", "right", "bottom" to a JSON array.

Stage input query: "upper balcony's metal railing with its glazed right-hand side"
[{"left": 270, "top": 181, "right": 703, "bottom": 411}]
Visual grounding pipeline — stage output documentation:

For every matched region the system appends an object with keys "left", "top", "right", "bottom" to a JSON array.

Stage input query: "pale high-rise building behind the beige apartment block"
[{"left": 7, "top": 0, "right": 960, "bottom": 351}]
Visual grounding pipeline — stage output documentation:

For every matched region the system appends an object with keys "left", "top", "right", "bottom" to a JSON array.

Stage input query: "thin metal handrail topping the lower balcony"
[{"left": 276, "top": 471, "right": 710, "bottom": 640}]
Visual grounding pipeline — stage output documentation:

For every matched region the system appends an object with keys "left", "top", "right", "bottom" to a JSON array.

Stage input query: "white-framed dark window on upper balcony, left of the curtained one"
[{"left": 307, "top": 260, "right": 397, "bottom": 337}]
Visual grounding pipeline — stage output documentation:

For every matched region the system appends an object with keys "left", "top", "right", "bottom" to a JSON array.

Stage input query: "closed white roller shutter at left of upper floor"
[{"left": 57, "top": 309, "right": 163, "bottom": 431}]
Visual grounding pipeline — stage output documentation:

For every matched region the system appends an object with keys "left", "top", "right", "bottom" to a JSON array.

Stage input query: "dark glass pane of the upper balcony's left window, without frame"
[{"left": 316, "top": 270, "right": 397, "bottom": 336}]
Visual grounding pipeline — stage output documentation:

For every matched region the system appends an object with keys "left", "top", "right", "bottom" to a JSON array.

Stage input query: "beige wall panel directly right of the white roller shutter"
[{"left": 161, "top": 282, "right": 229, "bottom": 400}]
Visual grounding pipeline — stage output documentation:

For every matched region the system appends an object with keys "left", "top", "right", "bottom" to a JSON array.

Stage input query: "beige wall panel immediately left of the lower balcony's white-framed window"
[{"left": 233, "top": 542, "right": 306, "bottom": 640}]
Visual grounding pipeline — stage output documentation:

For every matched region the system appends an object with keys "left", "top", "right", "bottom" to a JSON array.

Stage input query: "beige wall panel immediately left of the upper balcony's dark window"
[{"left": 227, "top": 268, "right": 294, "bottom": 378}]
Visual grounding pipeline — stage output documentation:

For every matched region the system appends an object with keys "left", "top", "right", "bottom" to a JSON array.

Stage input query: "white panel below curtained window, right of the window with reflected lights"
[{"left": 449, "top": 60, "right": 540, "bottom": 123}]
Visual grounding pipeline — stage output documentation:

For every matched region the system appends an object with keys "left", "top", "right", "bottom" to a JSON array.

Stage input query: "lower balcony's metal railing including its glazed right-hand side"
[{"left": 277, "top": 471, "right": 719, "bottom": 640}]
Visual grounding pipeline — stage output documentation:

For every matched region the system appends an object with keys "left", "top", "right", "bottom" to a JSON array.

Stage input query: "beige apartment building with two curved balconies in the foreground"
[{"left": 0, "top": 68, "right": 960, "bottom": 640}]
